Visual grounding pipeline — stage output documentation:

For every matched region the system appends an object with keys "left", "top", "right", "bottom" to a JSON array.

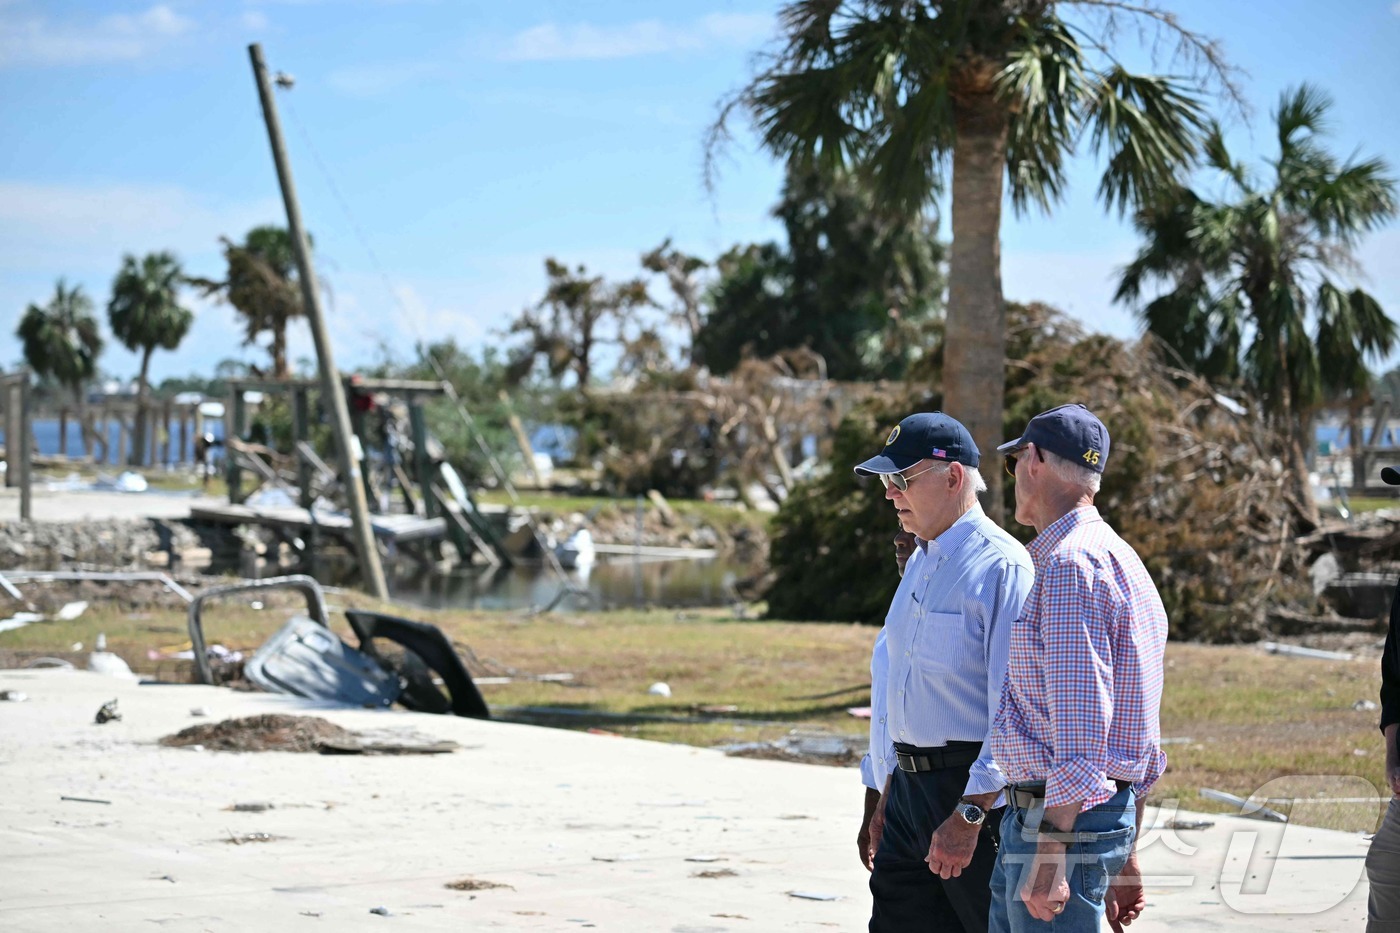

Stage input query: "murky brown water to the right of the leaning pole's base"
[{"left": 378, "top": 558, "right": 743, "bottom": 611}]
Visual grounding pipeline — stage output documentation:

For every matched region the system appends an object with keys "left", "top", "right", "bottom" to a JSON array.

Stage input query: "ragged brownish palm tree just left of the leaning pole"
[{"left": 190, "top": 226, "right": 311, "bottom": 380}]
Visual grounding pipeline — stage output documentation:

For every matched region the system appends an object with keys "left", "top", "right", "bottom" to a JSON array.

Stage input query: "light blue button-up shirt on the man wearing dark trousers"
[{"left": 879, "top": 504, "right": 1035, "bottom": 794}]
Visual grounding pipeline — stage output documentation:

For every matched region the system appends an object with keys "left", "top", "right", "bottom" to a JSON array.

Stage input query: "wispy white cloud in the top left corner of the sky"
[{"left": 0, "top": 4, "right": 195, "bottom": 67}]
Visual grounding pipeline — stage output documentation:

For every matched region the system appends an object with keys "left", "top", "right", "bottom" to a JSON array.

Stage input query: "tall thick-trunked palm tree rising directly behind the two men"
[{"left": 710, "top": 0, "right": 1228, "bottom": 516}]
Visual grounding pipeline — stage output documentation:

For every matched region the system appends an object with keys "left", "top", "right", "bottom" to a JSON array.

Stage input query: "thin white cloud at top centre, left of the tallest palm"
[{"left": 497, "top": 13, "right": 774, "bottom": 62}]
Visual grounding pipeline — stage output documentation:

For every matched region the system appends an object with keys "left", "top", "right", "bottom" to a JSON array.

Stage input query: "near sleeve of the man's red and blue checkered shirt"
[{"left": 1040, "top": 560, "right": 1114, "bottom": 807}]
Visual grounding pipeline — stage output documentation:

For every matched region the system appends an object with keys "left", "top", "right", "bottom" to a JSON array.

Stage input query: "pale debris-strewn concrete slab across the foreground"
[{"left": 0, "top": 671, "right": 1365, "bottom": 933}]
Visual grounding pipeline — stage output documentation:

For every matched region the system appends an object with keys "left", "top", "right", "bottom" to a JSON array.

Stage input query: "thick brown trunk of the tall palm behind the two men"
[{"left": 944, "top": 86, "right": 1008, "bottom": 521}]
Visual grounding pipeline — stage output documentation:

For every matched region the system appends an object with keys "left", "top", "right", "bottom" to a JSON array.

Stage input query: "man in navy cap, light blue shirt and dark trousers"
[{"left": 855, "top": 412, "right": 1032, "bottom": 933}]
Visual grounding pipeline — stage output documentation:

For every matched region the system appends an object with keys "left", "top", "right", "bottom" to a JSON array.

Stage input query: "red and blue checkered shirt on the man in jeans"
[{"left": 991, "top": 506, "right": 1166, "bottom": 810}]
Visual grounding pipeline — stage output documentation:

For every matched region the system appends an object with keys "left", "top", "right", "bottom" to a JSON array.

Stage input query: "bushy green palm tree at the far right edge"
[{"left": 1117, "top": 84, "right": 1396, "bottom": 524}]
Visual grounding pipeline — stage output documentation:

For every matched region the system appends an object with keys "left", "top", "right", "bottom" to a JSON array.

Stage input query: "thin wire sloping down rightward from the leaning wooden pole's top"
[{"left": 275, "top": 88, "right": 592, "bottom": 612}]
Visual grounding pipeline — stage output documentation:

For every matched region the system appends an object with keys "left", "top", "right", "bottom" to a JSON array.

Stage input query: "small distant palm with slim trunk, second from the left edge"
[{"left": 106, "top": 252, "right": 195, "bottom": 465}]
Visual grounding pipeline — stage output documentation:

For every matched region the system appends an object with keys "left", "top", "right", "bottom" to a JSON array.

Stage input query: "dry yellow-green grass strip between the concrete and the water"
[{"left": 0, "top": 594, "right": 1386, "bottom": 829}]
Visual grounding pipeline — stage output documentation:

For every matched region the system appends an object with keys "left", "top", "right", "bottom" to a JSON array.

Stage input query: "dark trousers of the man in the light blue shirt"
[{"left": 869, "top": 768, "right": 1001, "bottom": 933}]
